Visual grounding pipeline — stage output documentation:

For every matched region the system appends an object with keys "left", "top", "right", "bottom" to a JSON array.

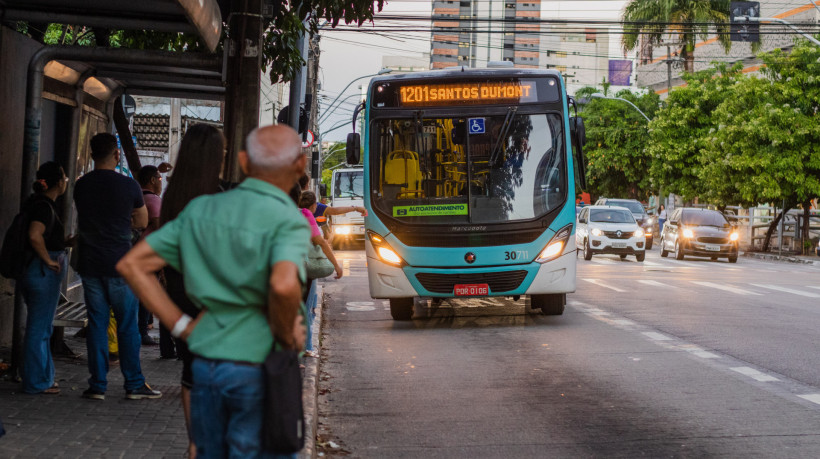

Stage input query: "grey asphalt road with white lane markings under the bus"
[{"left": 318, "top": 251, "right": 820, "bottom": 458}]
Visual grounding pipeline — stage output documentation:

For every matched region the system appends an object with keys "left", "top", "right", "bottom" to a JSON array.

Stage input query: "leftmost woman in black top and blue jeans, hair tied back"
[{"left": 20, "top": 161, "right": 68, "bottom": 394}]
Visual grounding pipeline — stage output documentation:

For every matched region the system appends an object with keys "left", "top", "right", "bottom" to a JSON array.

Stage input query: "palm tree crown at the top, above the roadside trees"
[{"left": 621, "top": 0, "right": 732, "bottom": 72}]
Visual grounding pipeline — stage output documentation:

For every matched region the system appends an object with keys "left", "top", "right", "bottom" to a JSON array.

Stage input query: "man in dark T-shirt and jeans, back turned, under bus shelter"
[{"left": 74, "top": 133, "right": 162, "bottom": 400}]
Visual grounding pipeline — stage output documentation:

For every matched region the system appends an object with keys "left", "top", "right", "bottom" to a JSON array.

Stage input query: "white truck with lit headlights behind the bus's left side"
[{"left": 330, "top": 167, "right": 364, "bottom": 248}]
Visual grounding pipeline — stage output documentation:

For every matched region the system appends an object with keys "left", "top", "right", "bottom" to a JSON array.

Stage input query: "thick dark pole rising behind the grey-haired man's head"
[{"left": 224, "top": 0, "right": 262, "bottom": 183}]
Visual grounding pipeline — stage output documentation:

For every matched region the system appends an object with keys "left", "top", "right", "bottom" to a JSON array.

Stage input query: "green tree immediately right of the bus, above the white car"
[{"left": 576, "top": 83, "right": 660, "bottom": 199}]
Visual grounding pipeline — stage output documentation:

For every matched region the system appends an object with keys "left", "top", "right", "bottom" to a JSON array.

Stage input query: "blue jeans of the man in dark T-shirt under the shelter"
[{"left": 83, "top": 276, "right": 145, "bottom": 392}]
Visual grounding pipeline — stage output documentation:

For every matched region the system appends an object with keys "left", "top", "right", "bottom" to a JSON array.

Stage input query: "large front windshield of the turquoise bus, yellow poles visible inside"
[{"left": 370, "top": 113, "right": 567, "bottom": 224}]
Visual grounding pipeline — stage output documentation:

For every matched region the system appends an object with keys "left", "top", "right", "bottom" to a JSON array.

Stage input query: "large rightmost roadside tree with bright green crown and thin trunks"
[{"left": 702, "top": 42, "right": 820, "bottom": 251}]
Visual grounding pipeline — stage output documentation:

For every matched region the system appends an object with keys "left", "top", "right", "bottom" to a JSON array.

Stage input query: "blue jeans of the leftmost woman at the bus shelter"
[{"left": 20, "top": 251, "right": 66, "bottom": 394}]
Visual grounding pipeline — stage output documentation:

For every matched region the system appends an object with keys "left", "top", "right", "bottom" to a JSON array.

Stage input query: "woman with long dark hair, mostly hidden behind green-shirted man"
[{"left": 159, "top": 124, "right": 225, "bottom": 458}]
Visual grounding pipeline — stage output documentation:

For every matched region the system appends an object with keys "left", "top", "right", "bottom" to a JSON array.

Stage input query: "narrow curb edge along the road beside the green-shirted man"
[{"left": 298, "top": 282, "right": 325, "bottom": 459}]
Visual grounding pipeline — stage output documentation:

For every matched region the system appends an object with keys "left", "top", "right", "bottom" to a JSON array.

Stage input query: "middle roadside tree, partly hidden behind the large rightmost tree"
[{"left": 647, "top": 64, "right": 742, "bottom": 200}]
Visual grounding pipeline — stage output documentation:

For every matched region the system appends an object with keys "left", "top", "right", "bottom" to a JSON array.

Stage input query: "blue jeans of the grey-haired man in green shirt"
[{"left": 191, "top": 357, "right": 296, "bottom": 459}]
